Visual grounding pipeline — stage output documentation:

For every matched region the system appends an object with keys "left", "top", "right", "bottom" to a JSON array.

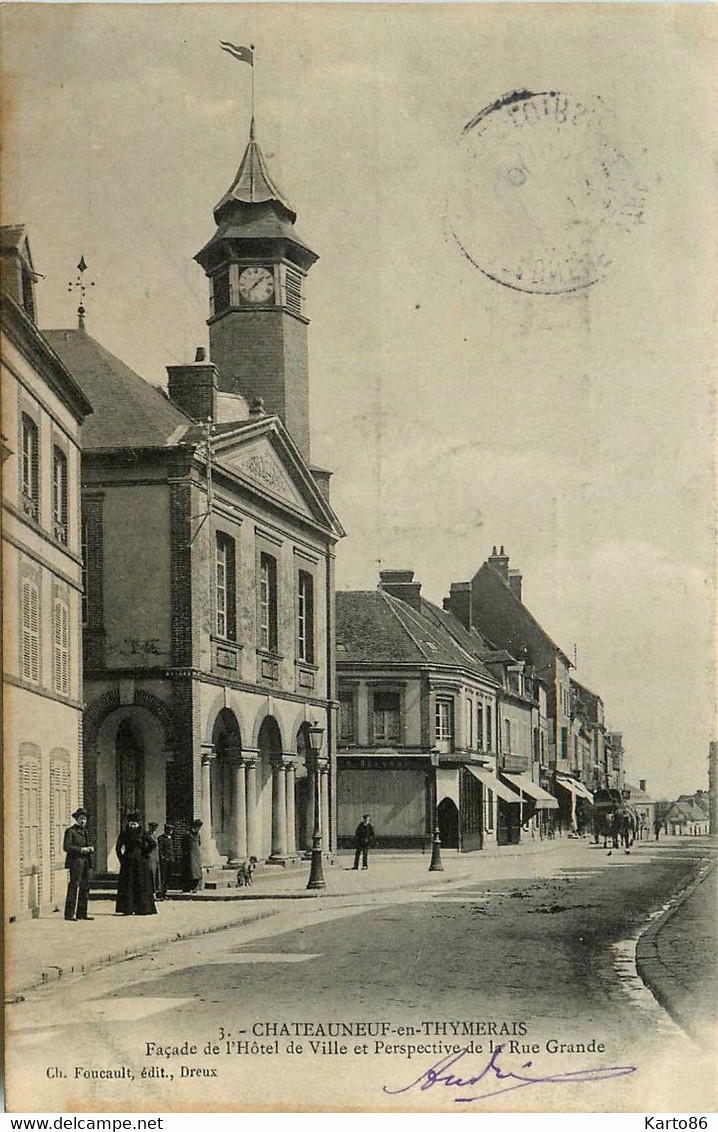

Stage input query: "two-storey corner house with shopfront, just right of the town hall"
[{"left": 336, "top": 571, "right": 557, "bottom": 851}]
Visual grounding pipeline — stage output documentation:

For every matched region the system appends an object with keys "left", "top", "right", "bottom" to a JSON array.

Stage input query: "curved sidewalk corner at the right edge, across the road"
[{"left": 635, "top": 864, "right": 717, "bottom": 1045}]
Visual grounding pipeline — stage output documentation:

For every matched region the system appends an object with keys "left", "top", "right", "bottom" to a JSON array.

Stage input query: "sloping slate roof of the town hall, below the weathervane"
[{"left": 43, "top": 329, "right": 194, "bottom": 451}]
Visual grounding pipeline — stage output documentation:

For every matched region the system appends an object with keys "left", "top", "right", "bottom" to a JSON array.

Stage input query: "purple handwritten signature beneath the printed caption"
[{"left": 384, "top": 1046, "right": 636, "bottom": 1105}]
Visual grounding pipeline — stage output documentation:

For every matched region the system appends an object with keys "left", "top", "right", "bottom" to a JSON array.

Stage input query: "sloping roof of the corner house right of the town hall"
[{"left": 336, "top": 590, "right": 495, "bottom": 683}]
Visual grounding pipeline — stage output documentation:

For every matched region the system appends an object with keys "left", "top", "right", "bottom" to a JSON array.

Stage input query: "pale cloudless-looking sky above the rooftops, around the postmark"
[{"left": 1, "top": 3, "right": 717, "bottom": 797}]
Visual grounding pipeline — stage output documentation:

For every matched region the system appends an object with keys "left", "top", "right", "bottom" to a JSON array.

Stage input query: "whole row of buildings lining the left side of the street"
[{"left": 1, "top": 106, "right": 624, "bottom": 917}]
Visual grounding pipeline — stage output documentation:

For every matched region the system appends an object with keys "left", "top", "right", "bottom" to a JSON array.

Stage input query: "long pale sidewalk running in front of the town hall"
[{"left": 5, "top": 839, "right": 575, "bottom": 1001}]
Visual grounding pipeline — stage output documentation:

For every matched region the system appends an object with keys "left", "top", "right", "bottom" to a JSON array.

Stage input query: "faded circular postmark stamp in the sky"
[{"left": 448, "top": 91, "right": 648, "bottom": 294}]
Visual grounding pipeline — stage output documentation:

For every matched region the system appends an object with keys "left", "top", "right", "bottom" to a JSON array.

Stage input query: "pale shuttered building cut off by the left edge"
[{"left": 1, "top": 225, "right": 92, "bottom": 919}]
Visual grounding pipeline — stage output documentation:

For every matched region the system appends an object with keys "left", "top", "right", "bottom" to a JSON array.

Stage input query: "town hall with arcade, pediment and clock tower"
[{"left": 49, "top": 130, "right": 343, "bottom": 872}]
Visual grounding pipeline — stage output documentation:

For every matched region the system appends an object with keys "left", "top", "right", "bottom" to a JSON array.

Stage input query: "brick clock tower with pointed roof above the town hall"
[{"left": 195, "top": 121, "right": 318, "bottom": 463}]
